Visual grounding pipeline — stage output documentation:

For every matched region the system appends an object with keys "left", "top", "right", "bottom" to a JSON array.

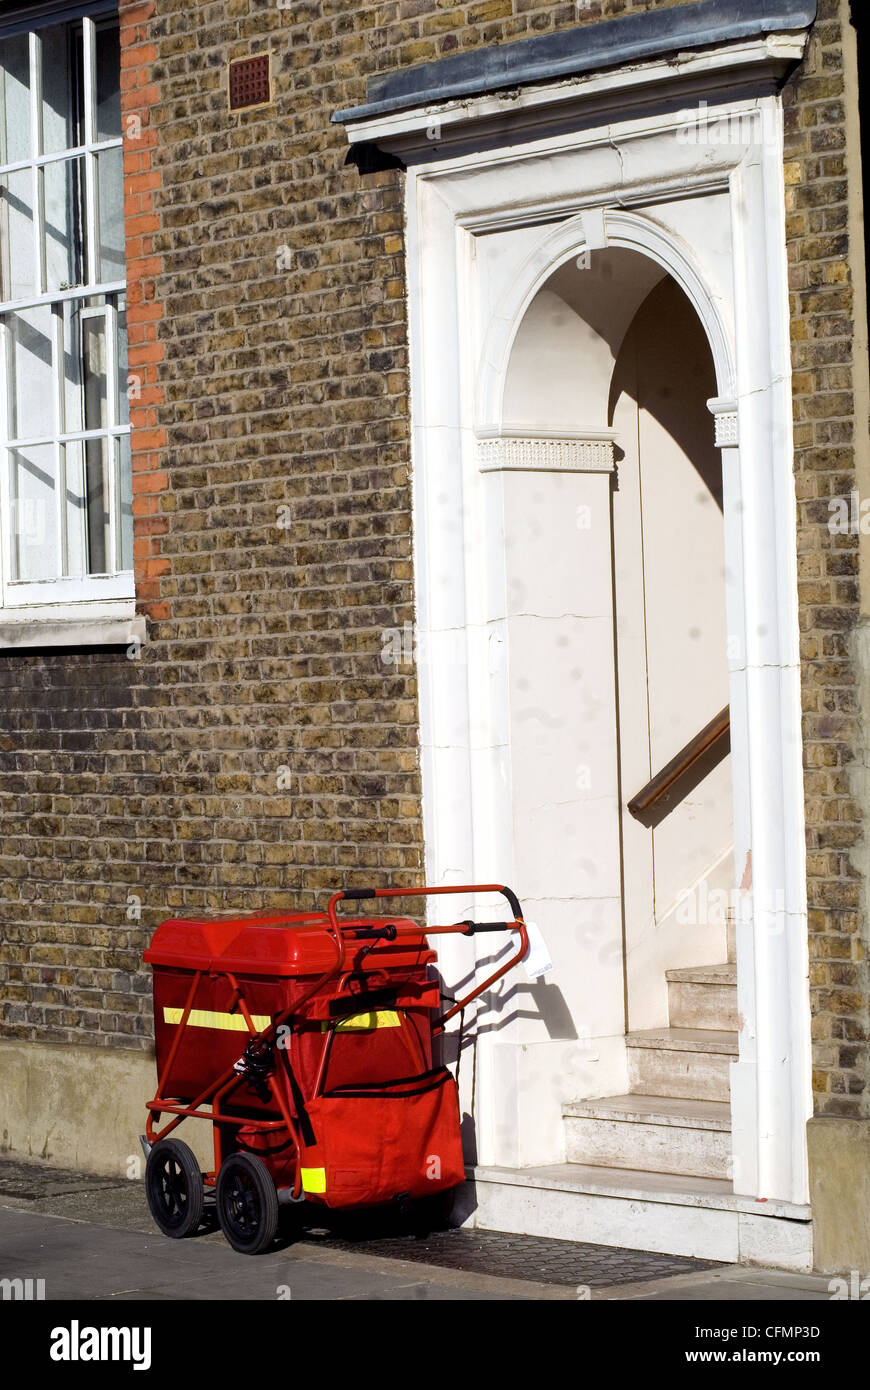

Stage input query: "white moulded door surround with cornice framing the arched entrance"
[{"left": 343, "top": 36, "right": 812, "bottom": 1202}]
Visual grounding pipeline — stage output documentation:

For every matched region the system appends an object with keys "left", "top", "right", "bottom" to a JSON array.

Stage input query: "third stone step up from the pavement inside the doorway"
[{"left": 625, "top": 1029, "right": 737, "bottom": 1101}]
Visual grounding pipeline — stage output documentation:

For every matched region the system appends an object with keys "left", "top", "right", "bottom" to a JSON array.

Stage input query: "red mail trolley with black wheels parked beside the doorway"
[{"left": 142, "top": 884, "right": 528, "bottom": 1255}]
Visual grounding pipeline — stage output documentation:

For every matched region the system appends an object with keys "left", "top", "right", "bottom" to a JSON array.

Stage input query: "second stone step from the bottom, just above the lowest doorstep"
[{"left": 561, "top": 1095, "right": 731, "bottom": 1177}]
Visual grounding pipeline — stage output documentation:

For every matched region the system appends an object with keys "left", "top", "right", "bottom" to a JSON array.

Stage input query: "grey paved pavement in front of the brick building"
[{"left": 0, "top": 1158, "right": 831, "bottom": 1302}]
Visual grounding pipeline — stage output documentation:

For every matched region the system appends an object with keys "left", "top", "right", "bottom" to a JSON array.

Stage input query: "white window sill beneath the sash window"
[{"left": 0, "top": 599, "right": 146, "bottom": 651}]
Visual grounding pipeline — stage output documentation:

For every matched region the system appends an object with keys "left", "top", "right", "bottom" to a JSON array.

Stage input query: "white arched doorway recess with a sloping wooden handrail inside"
[{"left": 502, "top": 247, "right": 737, "bottom": 1050}]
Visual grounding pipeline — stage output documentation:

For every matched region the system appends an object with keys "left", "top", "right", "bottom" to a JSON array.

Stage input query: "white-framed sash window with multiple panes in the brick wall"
[{"left": 0, "top": 7, "right": 133, "bottom": 642}]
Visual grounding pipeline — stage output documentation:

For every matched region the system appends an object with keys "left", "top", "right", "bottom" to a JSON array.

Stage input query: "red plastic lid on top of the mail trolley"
[{"left": 145, "top": 912, "right": 435, "bottom": 977}]
